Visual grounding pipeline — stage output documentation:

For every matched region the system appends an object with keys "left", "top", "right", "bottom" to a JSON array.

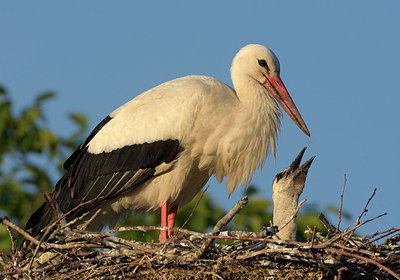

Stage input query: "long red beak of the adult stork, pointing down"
[{"left": 263, "top": 75, "right": 310, "bottom": 136}]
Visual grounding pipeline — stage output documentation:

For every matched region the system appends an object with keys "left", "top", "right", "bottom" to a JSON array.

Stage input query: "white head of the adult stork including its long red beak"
[{"left": 231, "top": 44, "right": 310, "bottom": 136}]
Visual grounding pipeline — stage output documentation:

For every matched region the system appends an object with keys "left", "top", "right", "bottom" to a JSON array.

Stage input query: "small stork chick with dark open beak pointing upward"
[{"left": 272, "top": 148, "right": 315, "bottom": 240}]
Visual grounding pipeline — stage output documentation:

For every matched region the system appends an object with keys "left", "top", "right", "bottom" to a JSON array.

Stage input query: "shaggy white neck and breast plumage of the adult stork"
[{"left": 209, "top": 75, "right": 282, "bottom": 195}]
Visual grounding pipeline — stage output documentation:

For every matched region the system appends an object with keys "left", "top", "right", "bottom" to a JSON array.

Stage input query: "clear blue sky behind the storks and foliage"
[{"left": 0, "top": 0, "right": 400, "bottom": 234}]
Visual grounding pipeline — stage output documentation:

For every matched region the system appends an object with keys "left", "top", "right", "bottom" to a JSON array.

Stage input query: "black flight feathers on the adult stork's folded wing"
[{"left": 26, "top": 112, "right": 182, "bottom": 236}]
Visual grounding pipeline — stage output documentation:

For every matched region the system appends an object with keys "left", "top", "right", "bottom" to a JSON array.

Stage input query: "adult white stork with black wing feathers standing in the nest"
[{"left": 26, "top": 44, "right": 310, "bottom": 241}]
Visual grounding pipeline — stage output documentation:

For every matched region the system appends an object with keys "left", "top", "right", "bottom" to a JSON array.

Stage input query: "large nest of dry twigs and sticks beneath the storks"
[{"left": 0, "top": 192, "right": 400, "bottom": 279}]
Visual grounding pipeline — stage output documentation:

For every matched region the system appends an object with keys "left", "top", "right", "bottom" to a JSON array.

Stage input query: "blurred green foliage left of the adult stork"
[{"left": 0, "top": 87, "right": 87, "bottom": 251}]
